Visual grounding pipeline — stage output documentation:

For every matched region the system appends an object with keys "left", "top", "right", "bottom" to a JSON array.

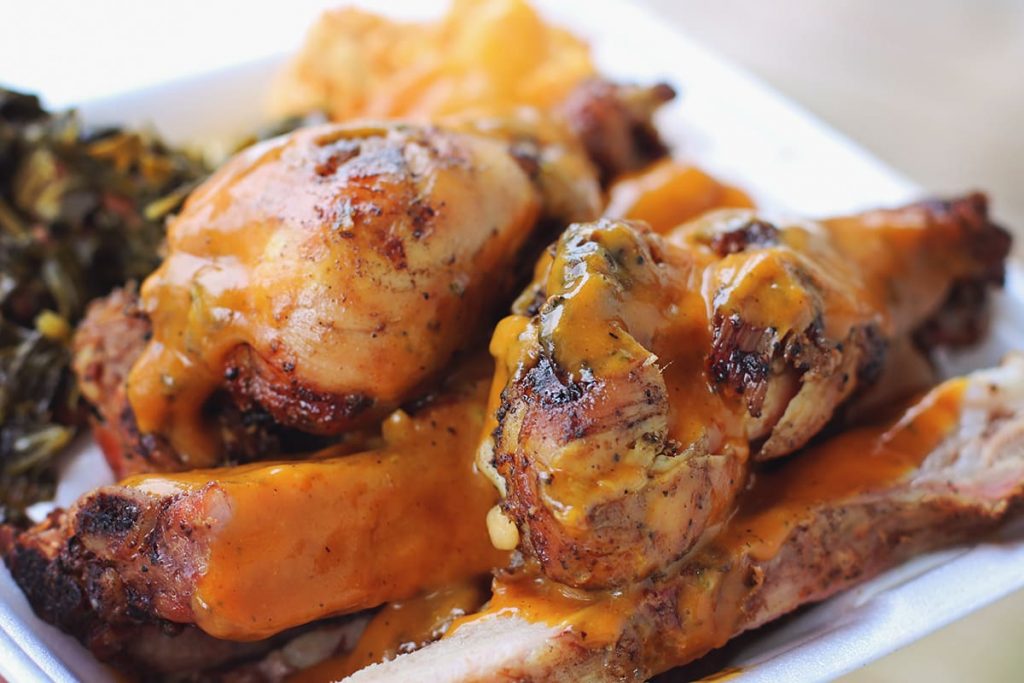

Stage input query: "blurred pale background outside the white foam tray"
[{"left": 0, "top": 0, "right": 1024, "bottom": 683}]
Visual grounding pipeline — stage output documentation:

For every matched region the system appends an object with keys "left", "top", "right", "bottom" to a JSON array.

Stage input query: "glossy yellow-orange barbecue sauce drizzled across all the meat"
[{"left": 126, "top": 148, "right": 963, "bottom": 680}]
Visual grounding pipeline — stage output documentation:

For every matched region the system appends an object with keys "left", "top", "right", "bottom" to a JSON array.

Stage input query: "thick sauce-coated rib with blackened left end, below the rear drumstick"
[{"left": 6, "top": 366, "right": 508, "bottom": 656}]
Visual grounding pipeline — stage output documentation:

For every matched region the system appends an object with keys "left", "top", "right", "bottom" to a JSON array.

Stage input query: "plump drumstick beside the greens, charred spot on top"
[{"left": 76, "top": 82, "right": 672, "bottom": 474}]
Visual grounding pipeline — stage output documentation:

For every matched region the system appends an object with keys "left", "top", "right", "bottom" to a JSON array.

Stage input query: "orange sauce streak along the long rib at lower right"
[{"left": 446, "top": 379, "right": 967, "bottom": 674}]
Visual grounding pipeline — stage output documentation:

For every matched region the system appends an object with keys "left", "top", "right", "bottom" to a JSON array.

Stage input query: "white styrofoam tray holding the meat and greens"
[{"left": 0, "top": 0, "right": 1024, "bottom": 681}]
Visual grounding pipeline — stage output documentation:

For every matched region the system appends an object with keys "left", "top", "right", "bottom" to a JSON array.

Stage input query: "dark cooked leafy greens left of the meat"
[{"left": 0, "top": 89, "right": 208, "bottom": 519}]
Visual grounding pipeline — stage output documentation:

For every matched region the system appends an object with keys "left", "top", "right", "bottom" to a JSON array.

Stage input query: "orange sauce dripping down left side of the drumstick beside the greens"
[{"left": 128, "top": 138, "right": 292, "bottom": 467}]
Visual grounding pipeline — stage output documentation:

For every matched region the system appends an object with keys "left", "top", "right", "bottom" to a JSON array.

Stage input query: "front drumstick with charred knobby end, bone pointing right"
[{"left": 480, "top": 196, "right": 1009, "bottom": 588}]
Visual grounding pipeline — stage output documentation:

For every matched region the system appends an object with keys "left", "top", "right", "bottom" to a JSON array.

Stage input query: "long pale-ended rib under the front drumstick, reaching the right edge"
[{"left": 358, "top": 355, "right": 1024, "bottom": 683}]
